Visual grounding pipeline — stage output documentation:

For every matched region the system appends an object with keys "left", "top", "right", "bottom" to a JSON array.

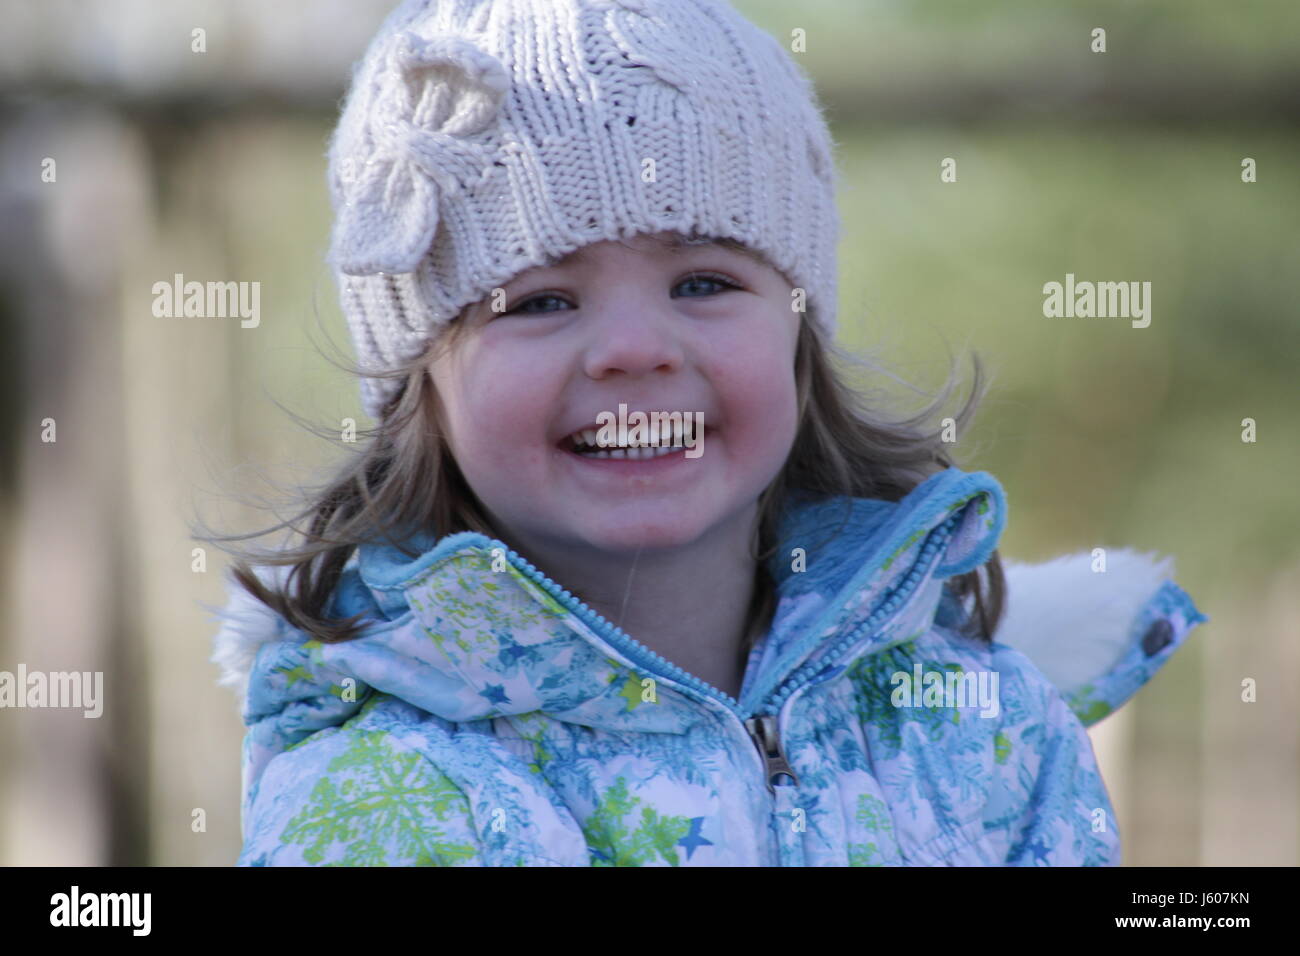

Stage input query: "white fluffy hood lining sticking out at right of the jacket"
[{"left": 993, "top": 549, "right": 1174, "bottom": 692}]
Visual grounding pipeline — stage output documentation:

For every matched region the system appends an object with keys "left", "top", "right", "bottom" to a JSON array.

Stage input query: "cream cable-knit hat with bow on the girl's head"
[{"left": 329, "top": 0, "right": 840, "bottom": 419}]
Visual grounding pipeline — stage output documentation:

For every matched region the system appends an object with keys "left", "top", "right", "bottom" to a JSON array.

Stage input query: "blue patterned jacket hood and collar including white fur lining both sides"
[{"left": 213, "top": 468, "right": 1205, "bottom": 816}]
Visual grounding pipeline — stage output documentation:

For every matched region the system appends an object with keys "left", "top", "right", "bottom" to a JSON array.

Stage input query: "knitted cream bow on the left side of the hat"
[{"left": 330, "top": 31, "right": 510, "bottom": 276}]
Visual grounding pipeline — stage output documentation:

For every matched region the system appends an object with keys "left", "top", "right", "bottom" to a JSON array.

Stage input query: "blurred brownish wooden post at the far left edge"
[{"left": 0, "top": 108, "right": 148, "bottom": 866}]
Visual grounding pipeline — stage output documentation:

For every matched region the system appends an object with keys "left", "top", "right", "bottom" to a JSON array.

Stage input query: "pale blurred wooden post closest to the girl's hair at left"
[{"left": 122, "top": 121, "right": 248, "bottom": 866}]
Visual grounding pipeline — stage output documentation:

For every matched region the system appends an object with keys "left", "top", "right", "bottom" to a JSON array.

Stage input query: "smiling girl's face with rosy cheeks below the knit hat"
[{"left": 430, "top": 233, "right": 801, "bottom": 553}]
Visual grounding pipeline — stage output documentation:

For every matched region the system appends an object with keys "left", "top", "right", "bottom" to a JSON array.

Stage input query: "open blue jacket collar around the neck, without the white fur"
[{"left": 258, "top": 468, "right": 1005, "bottom": 732}]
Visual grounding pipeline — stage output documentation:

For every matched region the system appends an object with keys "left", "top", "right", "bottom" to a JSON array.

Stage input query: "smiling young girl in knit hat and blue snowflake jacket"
[{"left": 215, "top": 0, "right": 1204, "bottom": 866}]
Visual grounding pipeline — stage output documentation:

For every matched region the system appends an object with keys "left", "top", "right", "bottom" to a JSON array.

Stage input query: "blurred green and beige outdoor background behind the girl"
[{"left": 0, "top": 0, "right": 1300, "bottom": 865}]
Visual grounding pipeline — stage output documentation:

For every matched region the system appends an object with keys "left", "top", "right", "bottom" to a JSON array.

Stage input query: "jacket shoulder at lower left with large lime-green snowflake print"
[{"left": 239, "top": 693, "right": 590, "bottom": 866}]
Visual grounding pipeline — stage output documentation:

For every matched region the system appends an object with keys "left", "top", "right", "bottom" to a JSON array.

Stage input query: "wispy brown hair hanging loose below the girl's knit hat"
[{"left": 195, "top": 261, "right": 1005, "bottom": 659}]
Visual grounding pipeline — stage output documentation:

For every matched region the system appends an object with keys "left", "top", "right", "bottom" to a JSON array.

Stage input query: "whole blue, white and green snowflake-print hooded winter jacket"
[{"left": 213, "top": 468, "right": 1206, "bottom": 866}]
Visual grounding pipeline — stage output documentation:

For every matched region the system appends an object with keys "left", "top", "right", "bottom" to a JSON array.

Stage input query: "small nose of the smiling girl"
[{"left": 584, "top": 295, "right": 685, "bottom": 380}]
